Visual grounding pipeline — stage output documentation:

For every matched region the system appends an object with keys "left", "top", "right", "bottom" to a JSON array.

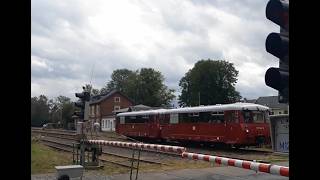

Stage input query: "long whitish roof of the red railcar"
[{"left": 117, "top": 103, "right": 269, "bottom": 116}]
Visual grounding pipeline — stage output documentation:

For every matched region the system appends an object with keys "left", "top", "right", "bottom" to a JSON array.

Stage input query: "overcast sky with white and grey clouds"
[{"left": 31, "top": 0, "right": 279, "bottom": 100}]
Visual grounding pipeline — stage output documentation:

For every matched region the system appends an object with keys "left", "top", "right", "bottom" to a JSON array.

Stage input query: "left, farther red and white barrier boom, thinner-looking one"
[{"left": 87, "top": 140, "right": 186, "bottom": 154}]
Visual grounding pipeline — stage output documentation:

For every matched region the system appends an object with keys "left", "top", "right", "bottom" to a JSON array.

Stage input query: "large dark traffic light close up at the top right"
[{"left": 265, "top": 0, "right": 289, "bottom": 103}]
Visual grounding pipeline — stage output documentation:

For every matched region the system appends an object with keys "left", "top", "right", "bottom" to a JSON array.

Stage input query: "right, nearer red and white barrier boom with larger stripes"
[{"left": 182, "top": 152, "right": 289, "bottom": 177}]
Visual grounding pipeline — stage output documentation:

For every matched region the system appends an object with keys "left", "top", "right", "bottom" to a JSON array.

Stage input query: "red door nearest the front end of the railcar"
[{"left": 225, "top": 111, "right": 240, "bottom": 144}]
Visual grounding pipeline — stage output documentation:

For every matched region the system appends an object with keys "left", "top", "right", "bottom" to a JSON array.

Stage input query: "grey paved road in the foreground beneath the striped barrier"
[{"left": 31, "top": 162, "right": 289, "bottom": 180}]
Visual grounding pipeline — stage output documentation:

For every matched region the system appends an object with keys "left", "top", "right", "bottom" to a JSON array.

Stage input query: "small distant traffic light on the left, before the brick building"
[{"left": 73, "top": 88, "right": 90, "bottom": 121}]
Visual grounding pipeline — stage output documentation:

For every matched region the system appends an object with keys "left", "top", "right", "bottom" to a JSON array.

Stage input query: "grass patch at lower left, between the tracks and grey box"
[{"left": 31, "top": 140, "right": 72, "bottom": 174}]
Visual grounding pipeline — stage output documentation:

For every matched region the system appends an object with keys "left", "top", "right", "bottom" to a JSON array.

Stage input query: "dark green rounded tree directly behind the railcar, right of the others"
[{"left": 179, "top": 59, "right": 241, "bottom": 106}]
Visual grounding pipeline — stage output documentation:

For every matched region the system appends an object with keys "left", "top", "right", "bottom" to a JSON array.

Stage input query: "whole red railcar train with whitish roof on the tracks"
[{"left": 116, "top": 103, "right": 270, "bottom": 146}]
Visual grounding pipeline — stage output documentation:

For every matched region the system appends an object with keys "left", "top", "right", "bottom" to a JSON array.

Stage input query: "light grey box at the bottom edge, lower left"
[{"left": 55, "top": 165, "right": 84, "bottom": 180}]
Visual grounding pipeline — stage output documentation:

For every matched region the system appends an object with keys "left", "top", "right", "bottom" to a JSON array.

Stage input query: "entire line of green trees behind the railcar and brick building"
[{"left": 31, "top": 59, "right": 241, "bottom": 127}]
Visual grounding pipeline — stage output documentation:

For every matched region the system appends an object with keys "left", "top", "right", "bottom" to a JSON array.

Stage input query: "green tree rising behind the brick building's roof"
[{"left": 101, "top": 68, "right": 175, "bottom": 106}]
